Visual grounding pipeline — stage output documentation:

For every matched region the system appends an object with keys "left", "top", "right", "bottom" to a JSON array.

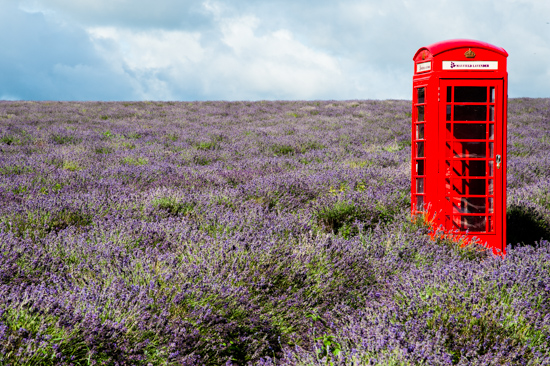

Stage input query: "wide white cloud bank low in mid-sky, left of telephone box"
[{"left": 84, "top": 5, "right": 356, "bottom": 100}]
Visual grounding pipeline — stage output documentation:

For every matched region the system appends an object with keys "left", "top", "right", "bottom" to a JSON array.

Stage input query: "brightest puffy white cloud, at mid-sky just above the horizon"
[{"left": 219, "top": 16, "right": 342, "bottom": 99}]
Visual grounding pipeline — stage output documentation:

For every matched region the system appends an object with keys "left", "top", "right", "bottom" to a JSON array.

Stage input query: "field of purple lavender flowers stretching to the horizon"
[{"left": 0, "top": 99, "right": 550, "bottom": 365}]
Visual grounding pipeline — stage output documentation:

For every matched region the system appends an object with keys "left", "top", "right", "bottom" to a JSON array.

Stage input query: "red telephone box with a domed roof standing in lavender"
[{"left": 411, "top": 39, "right": 508, "bottom": 254}]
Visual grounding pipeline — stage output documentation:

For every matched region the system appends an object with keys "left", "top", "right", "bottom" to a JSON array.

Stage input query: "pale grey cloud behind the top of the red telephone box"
[{"left": 212, "top": 0, "right": 550, "bottom": 97}]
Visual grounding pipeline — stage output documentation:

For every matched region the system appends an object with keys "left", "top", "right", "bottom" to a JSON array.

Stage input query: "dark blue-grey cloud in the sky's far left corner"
[{"left": 0, "top": 2, "right": 138, "bottom": 100}]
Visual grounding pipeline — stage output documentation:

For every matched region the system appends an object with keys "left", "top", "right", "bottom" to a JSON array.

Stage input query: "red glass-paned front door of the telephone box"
[{"left": 438, "top": 79, "right": 505, "bottom": 248}]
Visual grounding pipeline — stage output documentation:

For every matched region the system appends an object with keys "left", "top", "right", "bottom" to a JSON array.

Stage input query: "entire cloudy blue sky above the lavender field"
[{"left": 0, "top": 0, "right": 550, "bottom": 101}]
